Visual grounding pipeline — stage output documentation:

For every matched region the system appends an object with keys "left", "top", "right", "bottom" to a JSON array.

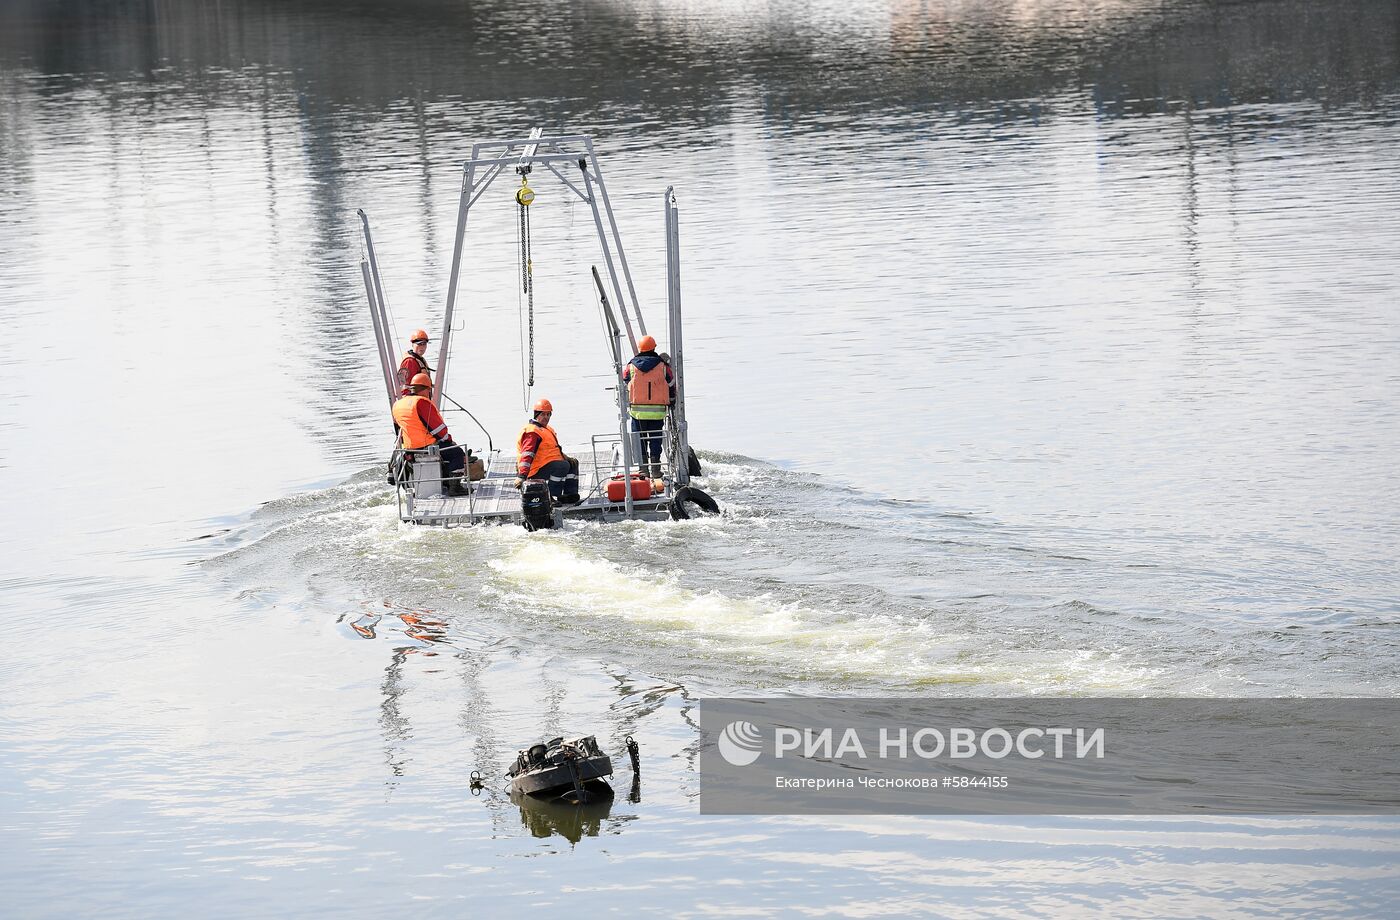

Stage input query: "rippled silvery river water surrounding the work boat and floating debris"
[{"left": 0, "top": 0, "right": 1400, "bottom": 917}]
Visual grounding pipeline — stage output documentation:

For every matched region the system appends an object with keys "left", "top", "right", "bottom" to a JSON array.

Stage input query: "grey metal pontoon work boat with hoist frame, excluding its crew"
[{"left": 358, "top": 129, "right": 720, "bottom": 531}]
